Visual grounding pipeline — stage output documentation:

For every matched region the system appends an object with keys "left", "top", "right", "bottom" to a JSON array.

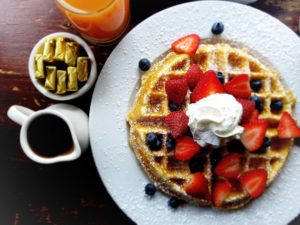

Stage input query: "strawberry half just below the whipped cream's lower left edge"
[{"left": 175, "top": 136, "right": 201, "bottom": 161}]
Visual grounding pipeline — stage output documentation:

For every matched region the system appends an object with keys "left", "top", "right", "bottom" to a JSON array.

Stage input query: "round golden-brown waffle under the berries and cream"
[{"left": 127, "top": 43, "right": 296, "bottom": 209}]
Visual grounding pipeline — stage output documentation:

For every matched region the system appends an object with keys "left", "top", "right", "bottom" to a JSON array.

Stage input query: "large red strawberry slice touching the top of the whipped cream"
[{"left": 191, "top": 70, "right": 224, "bottom": 103}]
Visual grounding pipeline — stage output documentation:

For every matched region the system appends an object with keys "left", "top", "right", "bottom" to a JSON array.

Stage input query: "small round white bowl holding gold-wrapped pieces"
[{"left": 28, "top": 32, "right": 97, "bottom": 101}]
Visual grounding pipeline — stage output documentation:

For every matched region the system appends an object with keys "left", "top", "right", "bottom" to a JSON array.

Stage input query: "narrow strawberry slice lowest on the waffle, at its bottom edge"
[{"left": 212, "top": 179, "right": 232, "bottom": 207}]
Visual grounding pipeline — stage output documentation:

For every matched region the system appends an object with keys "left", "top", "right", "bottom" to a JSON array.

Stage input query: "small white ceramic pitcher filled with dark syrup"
[{"left": 7, "top": 104, "right": 89, "bottom": 164}]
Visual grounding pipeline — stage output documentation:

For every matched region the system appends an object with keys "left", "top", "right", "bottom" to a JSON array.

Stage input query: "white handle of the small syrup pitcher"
[{"left": 7, "top": 105, "right": 34, "bottom": 125}]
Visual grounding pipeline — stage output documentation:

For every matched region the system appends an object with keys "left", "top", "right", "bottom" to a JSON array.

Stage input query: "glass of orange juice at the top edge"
[{"left": 55, "top": 0, "right": 130, "bottom": 44}]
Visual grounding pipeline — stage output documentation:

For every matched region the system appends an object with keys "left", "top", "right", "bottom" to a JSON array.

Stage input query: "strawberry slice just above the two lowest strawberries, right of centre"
[{"left": 214, "top": 153, "right": 242, "bottom": 179}]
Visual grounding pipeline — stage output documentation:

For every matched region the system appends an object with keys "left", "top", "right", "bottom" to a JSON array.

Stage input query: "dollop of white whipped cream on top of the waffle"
[{"left": 186, "top": 94, "right": 244, "bottom": 148}]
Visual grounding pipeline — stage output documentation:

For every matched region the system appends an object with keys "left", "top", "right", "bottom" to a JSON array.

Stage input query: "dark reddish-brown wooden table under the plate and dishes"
[{"left": 0, "top": 0, "right": 300, "bottom": 225}]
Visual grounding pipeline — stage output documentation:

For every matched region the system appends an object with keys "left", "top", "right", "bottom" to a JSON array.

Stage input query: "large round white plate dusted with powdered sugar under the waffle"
[{"left": 90, "top": 1, "right": 300, "bottom": 225}]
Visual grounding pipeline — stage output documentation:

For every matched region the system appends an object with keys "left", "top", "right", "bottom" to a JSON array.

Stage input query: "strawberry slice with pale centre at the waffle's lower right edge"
[{"left": 239, "top": 169, "right": 268, "bottom": 198}]
